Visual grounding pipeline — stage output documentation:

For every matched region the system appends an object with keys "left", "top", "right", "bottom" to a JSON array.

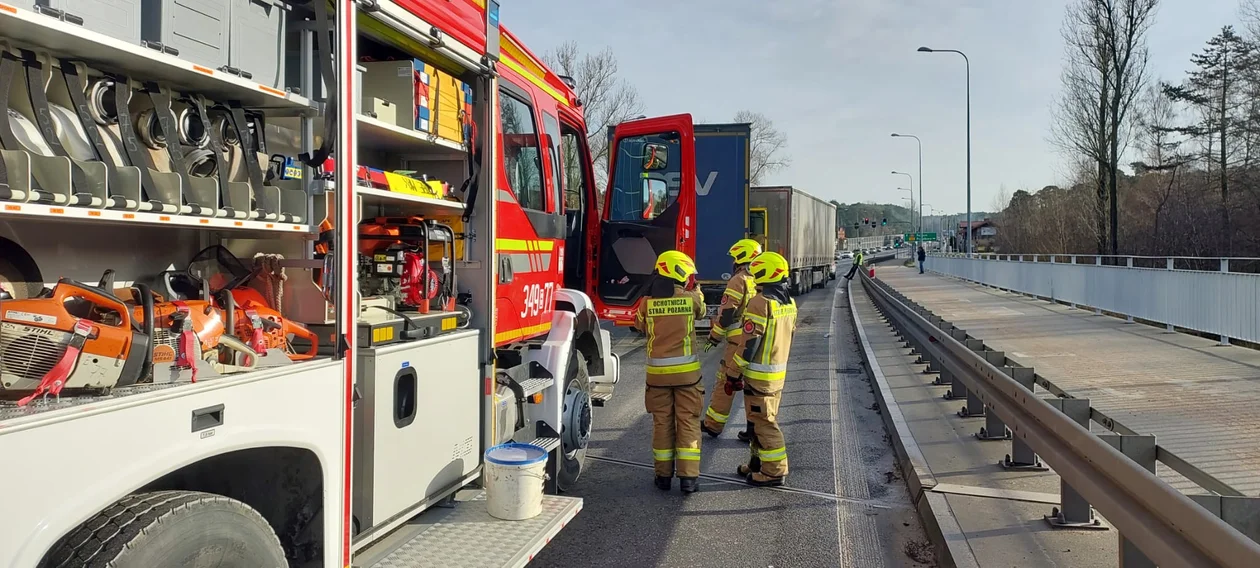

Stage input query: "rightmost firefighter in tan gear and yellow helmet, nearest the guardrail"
[{"left": 726, "top": 252, "right": 796, "bottom": 486}]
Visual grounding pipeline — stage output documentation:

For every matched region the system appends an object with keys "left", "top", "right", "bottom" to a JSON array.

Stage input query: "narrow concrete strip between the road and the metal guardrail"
[{"left": 838, "top": 280, "right": 1118, "bottom": 568}]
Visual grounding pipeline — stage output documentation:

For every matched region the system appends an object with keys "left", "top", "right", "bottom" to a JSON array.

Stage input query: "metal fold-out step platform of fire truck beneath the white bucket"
[{"left": 353, "top": 490, "right": 582, "bottom": 568}]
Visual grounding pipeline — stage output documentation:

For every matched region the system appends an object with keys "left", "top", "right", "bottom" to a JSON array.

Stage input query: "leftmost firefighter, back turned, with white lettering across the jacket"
[{"left": 635, "top": 251, "right": 704, "bottom": 492}]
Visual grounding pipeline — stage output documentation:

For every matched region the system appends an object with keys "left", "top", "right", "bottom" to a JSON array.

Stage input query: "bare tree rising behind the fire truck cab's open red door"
[{"left": 543, "top": 42, "right": 643, "bottom": 195}]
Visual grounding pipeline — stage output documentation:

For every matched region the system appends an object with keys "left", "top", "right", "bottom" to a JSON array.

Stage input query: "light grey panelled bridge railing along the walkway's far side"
[{"left": 926, "top": 253, "right": 1260, "bottom": 343}]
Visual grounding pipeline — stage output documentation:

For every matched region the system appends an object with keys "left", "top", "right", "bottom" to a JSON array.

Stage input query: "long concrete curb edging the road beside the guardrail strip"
[{"left": 845, "top": 282, "right": 980, "bottom": 568}]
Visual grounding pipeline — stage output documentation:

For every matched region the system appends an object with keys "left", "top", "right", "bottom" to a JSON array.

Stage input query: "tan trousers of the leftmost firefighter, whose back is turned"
[{"left": 644, "top": 383, "right": 704, "bottom": 477}]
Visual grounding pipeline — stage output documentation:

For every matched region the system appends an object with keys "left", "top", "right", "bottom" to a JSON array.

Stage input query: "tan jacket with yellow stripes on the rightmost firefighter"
[{"left": 735, "top": 283, "right": 796, "bottom": 394}]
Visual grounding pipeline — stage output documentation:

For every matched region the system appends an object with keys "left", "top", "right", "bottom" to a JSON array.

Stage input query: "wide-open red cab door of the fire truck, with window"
[{"left": 587, "top": 115, "right": 696, "bottom": 325}]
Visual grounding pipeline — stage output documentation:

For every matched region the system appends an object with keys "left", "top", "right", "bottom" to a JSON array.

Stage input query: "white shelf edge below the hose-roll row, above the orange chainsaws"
[{"left": 0, "top": 199, "right": 311, "bottom": 233}]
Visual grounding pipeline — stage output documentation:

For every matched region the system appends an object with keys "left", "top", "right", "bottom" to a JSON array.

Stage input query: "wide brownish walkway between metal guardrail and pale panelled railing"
[{"left": 876, "top": 264, "right": 1260, "bottom": 496}]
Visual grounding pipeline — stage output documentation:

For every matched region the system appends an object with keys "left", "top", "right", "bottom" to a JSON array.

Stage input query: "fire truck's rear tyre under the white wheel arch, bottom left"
[{"left": 40, "top": 491, "right": 289, "bottom": 568}]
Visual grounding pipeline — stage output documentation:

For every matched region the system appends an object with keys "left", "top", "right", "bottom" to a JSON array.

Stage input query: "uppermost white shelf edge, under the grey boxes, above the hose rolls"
[{"left": 0, "top": 4, "right": 311, "bottom": 108}]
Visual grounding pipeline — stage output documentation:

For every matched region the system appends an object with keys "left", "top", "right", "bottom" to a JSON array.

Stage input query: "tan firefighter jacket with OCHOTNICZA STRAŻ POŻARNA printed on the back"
[{"left": 634, "top": 281, "right": 704, "bottom": 387}]
